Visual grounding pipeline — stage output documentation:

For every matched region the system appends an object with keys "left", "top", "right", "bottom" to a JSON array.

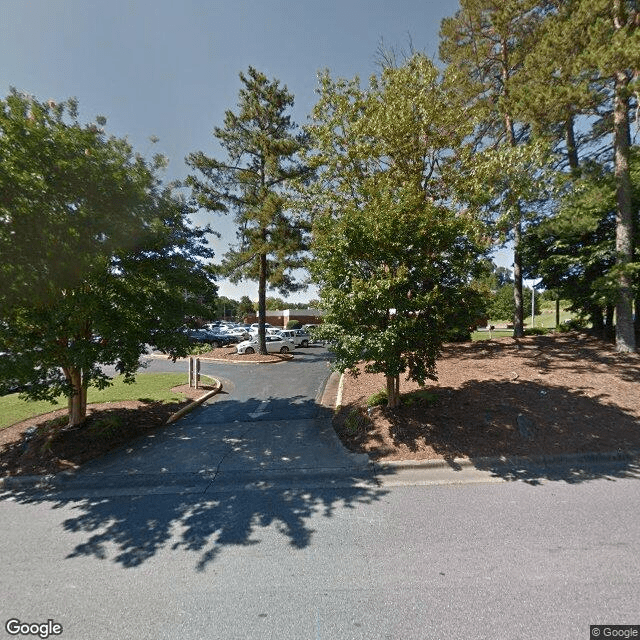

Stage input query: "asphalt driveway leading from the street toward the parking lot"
[{"left": 71, "top": 346, "right": 369, "bottom": 492}]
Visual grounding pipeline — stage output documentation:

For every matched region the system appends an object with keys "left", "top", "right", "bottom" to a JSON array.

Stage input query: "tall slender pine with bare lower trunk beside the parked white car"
[{"left": 187, "top": 67, "right": 309, "bottom": 353}]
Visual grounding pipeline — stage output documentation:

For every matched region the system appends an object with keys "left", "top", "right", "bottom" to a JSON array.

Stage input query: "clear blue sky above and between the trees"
[{"left": 0, "top": 0, "right": 508, "bottom": 301}]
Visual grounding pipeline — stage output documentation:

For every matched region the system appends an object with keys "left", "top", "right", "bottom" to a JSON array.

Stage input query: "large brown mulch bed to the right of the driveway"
[{"left": 334, "top": 333, "right": 640, "bottom": 460}]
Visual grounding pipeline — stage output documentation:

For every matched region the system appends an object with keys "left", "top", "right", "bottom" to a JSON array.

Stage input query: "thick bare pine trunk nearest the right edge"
[{"left": 613, "top": 71, "right": 636, "bottom": 352}]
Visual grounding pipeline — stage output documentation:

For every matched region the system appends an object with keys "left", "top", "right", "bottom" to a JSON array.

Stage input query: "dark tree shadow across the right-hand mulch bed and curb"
[{"left": 360, "top": 380, "right": 640, "bottom": 484}]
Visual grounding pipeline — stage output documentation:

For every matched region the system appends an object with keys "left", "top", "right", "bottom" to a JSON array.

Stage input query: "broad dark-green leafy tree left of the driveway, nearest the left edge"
[{"left": 0, "top": 92, "right": 215, "bottom": 425}]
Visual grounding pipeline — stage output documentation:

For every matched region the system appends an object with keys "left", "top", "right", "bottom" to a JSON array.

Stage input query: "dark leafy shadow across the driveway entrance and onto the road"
[{"left": 0, "top": 397, "right": 386, "bottom": 571}]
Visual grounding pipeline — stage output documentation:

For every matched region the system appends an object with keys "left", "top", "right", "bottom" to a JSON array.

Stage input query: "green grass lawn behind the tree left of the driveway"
[{"left": 0, "top": 373, "right": 187, "bottom": 429}]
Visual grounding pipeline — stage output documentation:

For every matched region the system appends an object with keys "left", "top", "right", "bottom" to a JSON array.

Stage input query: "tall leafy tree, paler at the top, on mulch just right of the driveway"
[{"left": 306, "top": 55, "right": 478, "bottom": 407}]
